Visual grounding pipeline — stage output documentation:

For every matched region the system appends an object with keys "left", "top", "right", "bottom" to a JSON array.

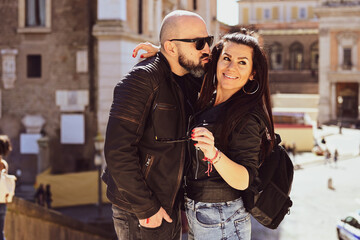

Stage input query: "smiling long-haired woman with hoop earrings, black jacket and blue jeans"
[{"left": 185, "top": 29, "right": 274, "bottom": 240}]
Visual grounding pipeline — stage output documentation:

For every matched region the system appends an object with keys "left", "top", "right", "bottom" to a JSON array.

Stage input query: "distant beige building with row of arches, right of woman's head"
[{"left": 238, "top": 0, "right": 319, "bottom": 94}]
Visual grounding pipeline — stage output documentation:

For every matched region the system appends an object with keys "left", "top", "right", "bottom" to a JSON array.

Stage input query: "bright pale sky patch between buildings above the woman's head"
[{"left": 217, "top": 0, "right": 239, "bottom": 25}]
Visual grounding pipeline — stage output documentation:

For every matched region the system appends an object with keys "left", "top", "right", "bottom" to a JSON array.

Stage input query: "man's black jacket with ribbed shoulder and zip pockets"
[{"left": 102, "top": 53, "right": 191, "bottom": 219}]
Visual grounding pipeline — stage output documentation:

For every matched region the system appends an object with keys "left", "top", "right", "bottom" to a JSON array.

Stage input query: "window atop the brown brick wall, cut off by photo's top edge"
[{"left": 26, "top": 0, "right": 46, "bottom": 27}]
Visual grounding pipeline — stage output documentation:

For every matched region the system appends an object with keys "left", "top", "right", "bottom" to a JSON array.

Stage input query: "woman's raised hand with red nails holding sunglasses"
[{"left": 191, "top": 127, "right": 216, "bottom": 159}]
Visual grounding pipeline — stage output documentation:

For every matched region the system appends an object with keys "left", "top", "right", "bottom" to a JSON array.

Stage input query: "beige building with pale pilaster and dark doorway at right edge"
[{"left": 315, "top": 1, "right": 360, "bottom": 124}]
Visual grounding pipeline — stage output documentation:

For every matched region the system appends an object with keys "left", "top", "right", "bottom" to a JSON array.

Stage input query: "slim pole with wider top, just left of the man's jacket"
[{"left": 94, "top": 133, "right": 104, "bottom": 219}]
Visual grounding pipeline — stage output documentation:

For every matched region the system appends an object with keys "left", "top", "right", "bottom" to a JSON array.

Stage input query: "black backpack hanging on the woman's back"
[{"left": 243, "top": 134, "right": 294, "bottom": 229}]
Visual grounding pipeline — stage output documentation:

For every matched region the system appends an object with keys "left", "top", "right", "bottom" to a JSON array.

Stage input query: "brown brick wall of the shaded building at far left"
[{"left": 0, "top": 0, "right": 96, "bottom": 182}]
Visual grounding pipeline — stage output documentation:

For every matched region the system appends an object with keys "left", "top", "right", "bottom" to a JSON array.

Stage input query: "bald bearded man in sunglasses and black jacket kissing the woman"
[{"left": 102, "top": 11, "right": 213, "bottom": 240}]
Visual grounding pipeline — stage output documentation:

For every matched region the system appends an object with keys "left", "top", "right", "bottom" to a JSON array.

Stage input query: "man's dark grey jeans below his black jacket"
[{"left": 112, "top": 205, "right": 181, "bottom": 240}]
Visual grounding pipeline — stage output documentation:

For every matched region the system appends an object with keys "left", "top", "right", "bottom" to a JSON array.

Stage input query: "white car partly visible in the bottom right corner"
[{"left": 336, "top": 211, "right": 360, "bottom": 240}]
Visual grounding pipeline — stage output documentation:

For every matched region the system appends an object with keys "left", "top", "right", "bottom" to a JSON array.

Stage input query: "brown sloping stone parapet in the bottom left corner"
[{"left": 5, "top": 197, "right": 116, "bottom": 240}]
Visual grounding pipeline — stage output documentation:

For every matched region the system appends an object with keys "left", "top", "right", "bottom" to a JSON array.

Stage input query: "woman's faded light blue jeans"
[{"left": 185, "top": 198, "right": 251, "bottom": 240}]
